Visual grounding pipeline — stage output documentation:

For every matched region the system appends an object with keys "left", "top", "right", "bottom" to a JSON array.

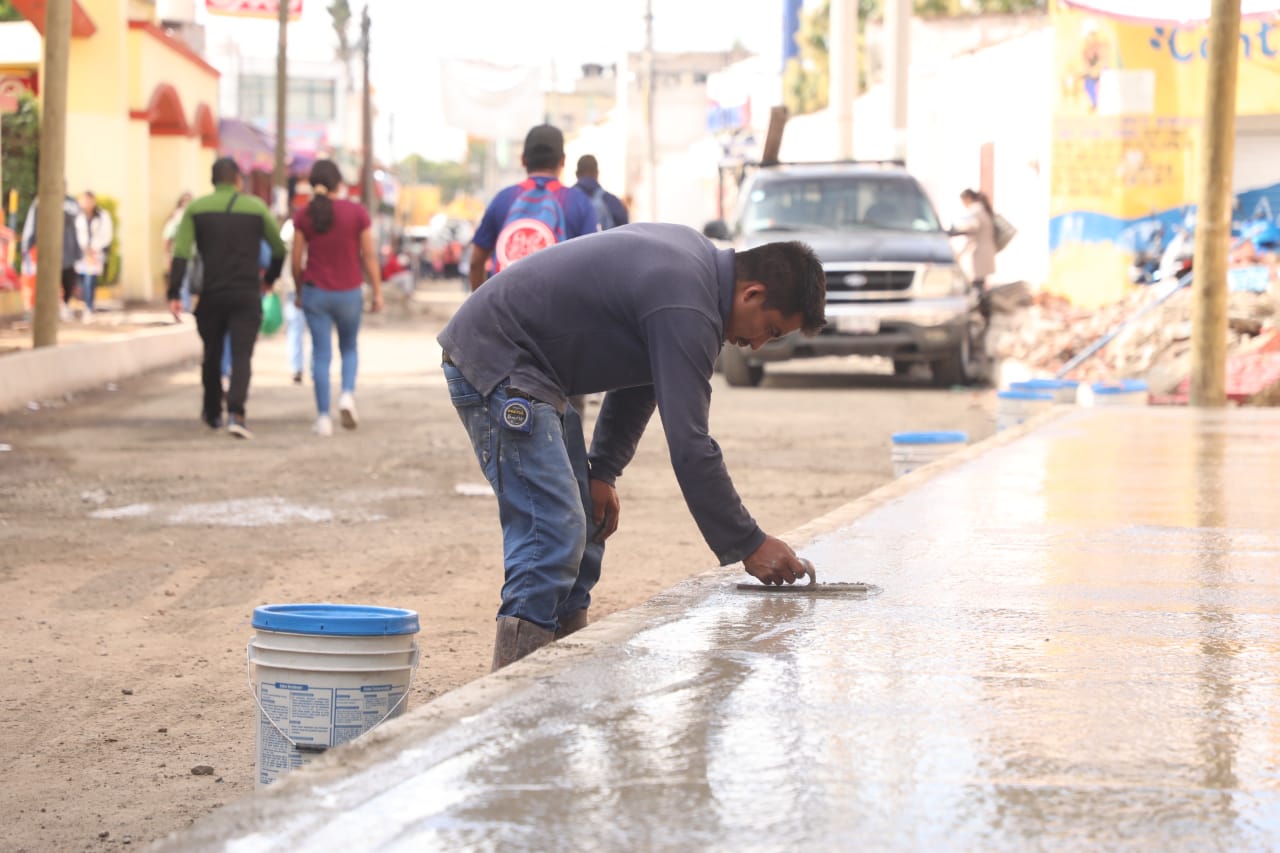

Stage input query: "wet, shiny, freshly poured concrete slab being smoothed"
[{"left": 161, "top": 409, "right": 1280, "bottom": 852}]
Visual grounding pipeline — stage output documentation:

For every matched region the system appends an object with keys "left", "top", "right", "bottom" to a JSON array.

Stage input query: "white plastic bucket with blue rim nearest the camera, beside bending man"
[{"left": 246, "top": 605, "right": 419, "bottom": 786}]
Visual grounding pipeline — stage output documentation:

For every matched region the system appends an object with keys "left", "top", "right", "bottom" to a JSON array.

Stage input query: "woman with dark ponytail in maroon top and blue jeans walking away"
[{"left": 289, "top": 160, "right": 383, "bottom": 435}]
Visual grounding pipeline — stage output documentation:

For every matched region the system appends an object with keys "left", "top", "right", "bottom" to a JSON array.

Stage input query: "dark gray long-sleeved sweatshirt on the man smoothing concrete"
[{"left": 438, "top": 223, "right": 764, "bottom": 565}]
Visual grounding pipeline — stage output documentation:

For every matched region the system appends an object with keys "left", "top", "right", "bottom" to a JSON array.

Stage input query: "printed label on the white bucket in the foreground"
[{"left": 257, "top": 681, "right": 406, "bottom": 785}]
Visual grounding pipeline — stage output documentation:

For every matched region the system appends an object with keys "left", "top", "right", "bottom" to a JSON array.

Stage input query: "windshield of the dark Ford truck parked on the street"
[{"left": 740, "top": 175, "right": 942, "bottom": 233}]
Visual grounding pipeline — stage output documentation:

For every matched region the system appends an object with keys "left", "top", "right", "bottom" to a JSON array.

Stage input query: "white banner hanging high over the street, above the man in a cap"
[{"left": 440, "top": 59, "right": 545, "bottom": 140}]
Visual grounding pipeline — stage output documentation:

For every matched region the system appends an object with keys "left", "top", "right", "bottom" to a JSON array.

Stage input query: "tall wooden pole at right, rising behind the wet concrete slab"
[{"left": 1190, "top": 0, "right": 1240, "bottom": 407}]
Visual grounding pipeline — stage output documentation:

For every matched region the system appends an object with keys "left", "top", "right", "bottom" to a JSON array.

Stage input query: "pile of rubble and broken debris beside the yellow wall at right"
[{"left": 987, "top": 282, "right": 1280, "bottom": 396}]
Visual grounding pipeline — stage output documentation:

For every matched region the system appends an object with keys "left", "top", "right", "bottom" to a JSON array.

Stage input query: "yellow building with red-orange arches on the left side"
[{"left": 0, "top": 0, "right": 219, "bottom": 306}]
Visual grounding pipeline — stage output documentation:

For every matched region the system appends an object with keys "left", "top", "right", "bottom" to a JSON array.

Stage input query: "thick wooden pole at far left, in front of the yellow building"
[{"left": 31, "top": 0, "right": 72, "bottom": 347}]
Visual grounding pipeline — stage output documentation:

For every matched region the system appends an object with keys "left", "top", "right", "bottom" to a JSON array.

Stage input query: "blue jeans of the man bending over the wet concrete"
[{"left": 444, "top": 364, "right": 604, "bottom": 631}]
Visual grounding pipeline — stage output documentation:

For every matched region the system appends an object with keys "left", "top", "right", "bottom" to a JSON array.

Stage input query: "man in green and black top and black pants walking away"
[{"left": 169, "top": 158, "right": 284, "bottom": 438}]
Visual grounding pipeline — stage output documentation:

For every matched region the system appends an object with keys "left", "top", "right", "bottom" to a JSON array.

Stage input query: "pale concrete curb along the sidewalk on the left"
[{"left": 0, "top": 323, "right": 201, "bottom": 414}]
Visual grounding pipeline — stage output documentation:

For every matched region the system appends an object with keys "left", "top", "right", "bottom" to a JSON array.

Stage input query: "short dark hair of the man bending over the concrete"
[{"left": 733, "top": 241, "right": 827, "bottom": 334}]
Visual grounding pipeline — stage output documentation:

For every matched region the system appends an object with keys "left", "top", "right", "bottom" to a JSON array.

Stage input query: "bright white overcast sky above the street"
[{"left": 200, "top": 0, "right": 782, "bottom": 160}]
